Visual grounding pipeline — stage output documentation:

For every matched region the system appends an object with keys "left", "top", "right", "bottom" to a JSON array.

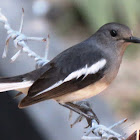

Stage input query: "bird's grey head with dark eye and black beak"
[{"left": 96, "top": 23, "right": 140, "bottom": 48}]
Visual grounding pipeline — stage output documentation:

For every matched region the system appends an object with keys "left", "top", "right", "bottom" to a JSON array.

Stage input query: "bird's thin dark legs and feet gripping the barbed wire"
[{"left": 61, "top": 101, "right": 99, "bottom": 125}]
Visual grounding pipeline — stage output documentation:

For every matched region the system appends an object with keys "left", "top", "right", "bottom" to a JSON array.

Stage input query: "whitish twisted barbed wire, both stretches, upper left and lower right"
[{"left": 0, "top": 9, "right": 127, "bottom": 140}]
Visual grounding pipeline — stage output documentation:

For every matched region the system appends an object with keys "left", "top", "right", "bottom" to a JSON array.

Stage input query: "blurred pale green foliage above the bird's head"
[{"left": 73, "top": 0, "right": 140, "bottom": 30}]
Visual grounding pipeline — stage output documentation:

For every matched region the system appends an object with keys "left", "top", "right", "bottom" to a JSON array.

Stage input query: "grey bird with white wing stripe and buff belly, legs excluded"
[{"left": 0, "top": 22, "right": 140, "bottom": 114}]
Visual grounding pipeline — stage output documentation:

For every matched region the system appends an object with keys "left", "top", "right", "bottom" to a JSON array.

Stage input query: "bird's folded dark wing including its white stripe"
[{"left": 20, "top": 42, "right": 107, "bottom": 107}]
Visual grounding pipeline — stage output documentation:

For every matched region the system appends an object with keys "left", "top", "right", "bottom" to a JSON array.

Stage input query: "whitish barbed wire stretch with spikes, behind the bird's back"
[{"left": 0, "top": 8, "right": 49, "bottom": 68}]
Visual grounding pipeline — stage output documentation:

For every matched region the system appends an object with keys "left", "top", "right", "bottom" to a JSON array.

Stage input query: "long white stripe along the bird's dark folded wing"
[{"left": 36, "top": 59, "right": 106, "bottom": 96}]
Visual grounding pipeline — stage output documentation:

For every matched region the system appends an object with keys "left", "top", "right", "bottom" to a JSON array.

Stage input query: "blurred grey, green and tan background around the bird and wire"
[{"left": 0, "top": 0, "right": 140, "bottom": 140}]
